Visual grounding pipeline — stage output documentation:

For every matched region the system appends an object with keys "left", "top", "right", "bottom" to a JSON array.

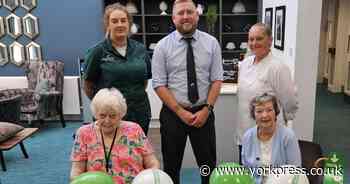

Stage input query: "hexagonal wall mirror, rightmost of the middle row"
[{"left": 22, "top": 13, "right": 39, "bottom": 39}]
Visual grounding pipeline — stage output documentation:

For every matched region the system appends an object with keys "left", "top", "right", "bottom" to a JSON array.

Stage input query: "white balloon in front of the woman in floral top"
[{"left": 132, "top": 169, "right": 174, "bottom": 184}]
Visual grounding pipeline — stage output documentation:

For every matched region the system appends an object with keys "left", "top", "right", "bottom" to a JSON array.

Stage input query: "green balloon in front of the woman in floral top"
[{"left": 70, "top": 172, "right": 114, "bottom": 184}]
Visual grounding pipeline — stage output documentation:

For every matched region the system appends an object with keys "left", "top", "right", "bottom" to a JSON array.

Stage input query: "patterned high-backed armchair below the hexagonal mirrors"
[{"left": 0, "top": 61, "right": 66, "bottom": 127}]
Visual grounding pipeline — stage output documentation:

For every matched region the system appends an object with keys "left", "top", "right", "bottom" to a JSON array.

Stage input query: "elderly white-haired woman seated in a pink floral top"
[{"left": 71, "top": 88, "right": 160, "bottom": 184}]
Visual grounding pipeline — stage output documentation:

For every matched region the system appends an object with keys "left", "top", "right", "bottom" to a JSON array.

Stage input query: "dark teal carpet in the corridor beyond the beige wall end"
[{"left": 314, "top": 84, "right": 350, "bottom": 184}]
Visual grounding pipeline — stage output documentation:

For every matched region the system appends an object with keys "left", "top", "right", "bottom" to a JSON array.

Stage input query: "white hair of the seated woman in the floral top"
[{"left": 90, "top": 88, "right": 127, "bottom": 118}]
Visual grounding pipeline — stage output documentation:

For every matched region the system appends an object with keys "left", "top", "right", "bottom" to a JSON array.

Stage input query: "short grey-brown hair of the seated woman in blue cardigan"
[{"left": 249, "top": 93, "right": 280, "bottom": 120}]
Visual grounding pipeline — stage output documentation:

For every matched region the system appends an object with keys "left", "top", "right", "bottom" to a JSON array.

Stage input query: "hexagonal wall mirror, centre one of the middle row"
[{"left": 6, "top": 13, "right": 22, "bottom": 39}]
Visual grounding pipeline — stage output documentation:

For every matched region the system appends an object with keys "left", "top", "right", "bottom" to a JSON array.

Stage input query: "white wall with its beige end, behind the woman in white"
[{"left": 263, "top": 0, "right": 322, "bottom": 140}]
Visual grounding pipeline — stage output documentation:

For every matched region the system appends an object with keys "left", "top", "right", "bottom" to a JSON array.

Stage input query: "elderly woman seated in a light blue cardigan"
[{"left": 242, "top": 93, "right": 301, "bottom": 184}]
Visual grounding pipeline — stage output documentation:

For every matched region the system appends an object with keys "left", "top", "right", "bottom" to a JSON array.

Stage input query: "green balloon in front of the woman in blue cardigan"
[{"left": 209, "top": 162, "right": 255, "bottom": 184}]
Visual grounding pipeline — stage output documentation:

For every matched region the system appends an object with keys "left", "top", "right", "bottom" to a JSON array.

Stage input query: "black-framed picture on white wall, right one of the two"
[{"left": 274, "top": 6, "right": 286, "bottom": 50}]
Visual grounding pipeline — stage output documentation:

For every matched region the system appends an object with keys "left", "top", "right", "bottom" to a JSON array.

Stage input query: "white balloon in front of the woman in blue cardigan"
[{"left": 266, "top": 165, "right": 309, "bottom": 184}]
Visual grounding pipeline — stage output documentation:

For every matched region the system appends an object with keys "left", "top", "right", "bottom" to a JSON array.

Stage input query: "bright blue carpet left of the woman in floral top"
[{"left": 0, "top": 122, "right": 81, "bottom": 184}]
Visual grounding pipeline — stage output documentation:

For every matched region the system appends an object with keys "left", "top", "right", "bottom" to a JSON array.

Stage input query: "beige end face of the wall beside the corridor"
[{"left": 295, "top": 0, "right": 322, "bottom": 140}]
